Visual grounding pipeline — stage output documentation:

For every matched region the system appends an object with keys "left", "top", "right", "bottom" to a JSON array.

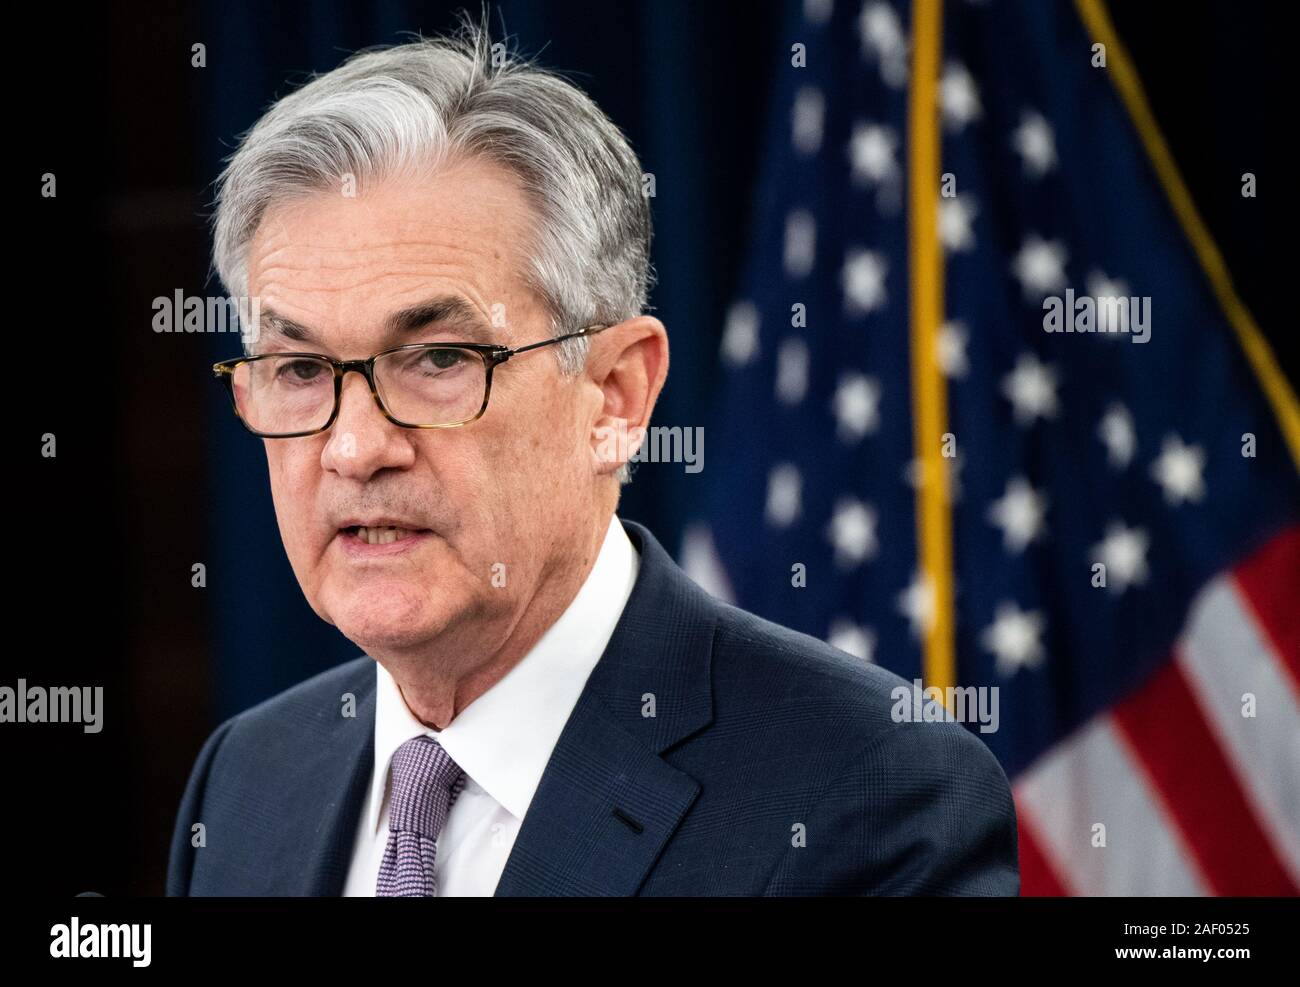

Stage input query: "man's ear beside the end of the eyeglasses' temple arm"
[{"left": 588, "top": 315, "right": 668, "bottom": 475}]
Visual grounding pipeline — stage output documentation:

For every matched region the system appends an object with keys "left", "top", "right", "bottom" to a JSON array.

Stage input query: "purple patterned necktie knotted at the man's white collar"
[{"left": 374, "top": 736, "right": 465, "bottom": 897}]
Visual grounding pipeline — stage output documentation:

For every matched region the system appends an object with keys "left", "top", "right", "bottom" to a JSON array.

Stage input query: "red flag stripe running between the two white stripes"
[{"left": 1113, "top": 662, "right": 1296, "bottom": 895}]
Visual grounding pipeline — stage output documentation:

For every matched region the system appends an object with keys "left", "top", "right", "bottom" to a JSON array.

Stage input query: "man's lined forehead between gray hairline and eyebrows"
[{"left": 248, "top": 159, "right": 537, "bottom": 345}]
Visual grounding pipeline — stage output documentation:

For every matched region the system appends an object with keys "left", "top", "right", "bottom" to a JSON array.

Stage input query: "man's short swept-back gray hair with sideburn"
[{"left": 213, "top": 12, "right": 655, "bottom": 482}]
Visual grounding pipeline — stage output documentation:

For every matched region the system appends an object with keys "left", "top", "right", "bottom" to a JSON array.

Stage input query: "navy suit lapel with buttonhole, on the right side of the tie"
[{"left": 495, "top": 521, "right": 714, "bottom": 896}]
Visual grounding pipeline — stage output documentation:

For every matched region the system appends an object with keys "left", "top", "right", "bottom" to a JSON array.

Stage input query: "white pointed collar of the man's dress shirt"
[{"left": 367, "top": 515, "right": 640, "bottom": 832}]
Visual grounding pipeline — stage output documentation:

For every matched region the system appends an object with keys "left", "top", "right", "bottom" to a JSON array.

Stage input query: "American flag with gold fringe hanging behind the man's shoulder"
[{"left": 681, "top": 0, "right": 1300, "bottom": 895}]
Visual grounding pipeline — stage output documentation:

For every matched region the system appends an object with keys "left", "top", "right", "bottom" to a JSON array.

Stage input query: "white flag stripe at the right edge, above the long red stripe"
[{"left": 1178, "top": 579, "right": 1300, "bottom": 882}]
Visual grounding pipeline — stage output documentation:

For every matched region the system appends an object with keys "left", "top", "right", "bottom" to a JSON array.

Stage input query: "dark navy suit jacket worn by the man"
[{"left": 166, "top": 521, "right": 1019, "bottom": 896}]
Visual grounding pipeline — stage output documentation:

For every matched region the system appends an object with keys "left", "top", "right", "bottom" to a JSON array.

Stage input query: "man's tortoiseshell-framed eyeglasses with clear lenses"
[{"left": 212, "top": 325, "right": 610, "bottom": 438}]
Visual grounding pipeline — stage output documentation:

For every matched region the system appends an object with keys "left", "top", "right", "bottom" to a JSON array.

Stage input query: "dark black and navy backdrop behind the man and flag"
[{"left": 15, "top": 0, "right": 1296, "bottom": 896}]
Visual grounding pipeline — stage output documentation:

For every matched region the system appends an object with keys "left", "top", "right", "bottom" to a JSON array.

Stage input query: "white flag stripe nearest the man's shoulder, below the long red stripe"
[{"left": 1015, "top": 715, "right": 1208, "bottom": 896}]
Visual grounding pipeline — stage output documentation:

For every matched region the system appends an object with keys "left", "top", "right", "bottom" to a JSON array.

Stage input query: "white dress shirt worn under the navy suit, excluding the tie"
[{"left": 343, "top": 515, "right": 640, "bottom": 897}]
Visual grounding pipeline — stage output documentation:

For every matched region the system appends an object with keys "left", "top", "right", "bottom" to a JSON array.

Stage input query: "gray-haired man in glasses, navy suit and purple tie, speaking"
[{"left": 168, "top": 15, "right": 1019, "bottom": 896}]
